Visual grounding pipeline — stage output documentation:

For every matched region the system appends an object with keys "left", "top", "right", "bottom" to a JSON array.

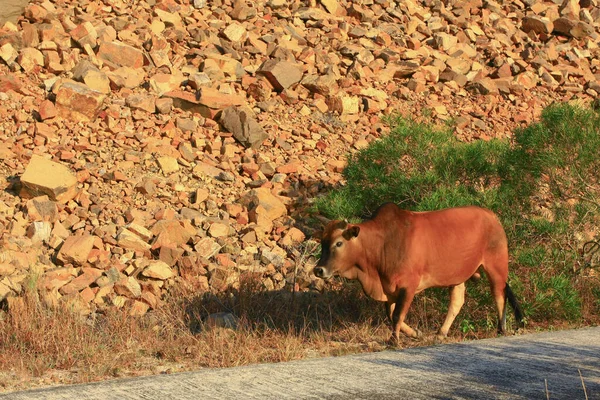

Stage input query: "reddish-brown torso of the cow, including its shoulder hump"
[{"left": 373, "top": 205, "right": 508, "bottom": 288}]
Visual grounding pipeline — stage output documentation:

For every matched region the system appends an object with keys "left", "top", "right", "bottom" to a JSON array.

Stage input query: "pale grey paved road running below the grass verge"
[{"left": 0, "top": 327, "right": 600, "bottom": 400}]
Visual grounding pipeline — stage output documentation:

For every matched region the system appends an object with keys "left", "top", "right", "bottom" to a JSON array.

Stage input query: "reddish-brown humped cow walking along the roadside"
[{"left": 314, "top": 203, "right": 522, "bottom": 341}]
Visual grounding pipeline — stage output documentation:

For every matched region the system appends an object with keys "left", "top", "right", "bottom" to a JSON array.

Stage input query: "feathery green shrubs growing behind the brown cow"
[{"left": 314, "top": 104, "right": 600, "bottom": 325}]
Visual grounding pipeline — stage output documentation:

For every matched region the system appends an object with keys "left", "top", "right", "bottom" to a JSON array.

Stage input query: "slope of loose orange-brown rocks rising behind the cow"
[{"left": 0, "top": 0, "right": 600, "bottom": 315}]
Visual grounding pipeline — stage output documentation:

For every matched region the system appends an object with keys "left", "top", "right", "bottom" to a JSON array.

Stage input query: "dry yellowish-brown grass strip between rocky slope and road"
[{"left": 0, "top": 275, "right": 592, "bottom": 392}]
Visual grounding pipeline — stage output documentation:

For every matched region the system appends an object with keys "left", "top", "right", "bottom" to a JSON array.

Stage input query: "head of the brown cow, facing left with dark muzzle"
[{"left": 313, "top": 221, "right": 360, "bottom": 279}]
